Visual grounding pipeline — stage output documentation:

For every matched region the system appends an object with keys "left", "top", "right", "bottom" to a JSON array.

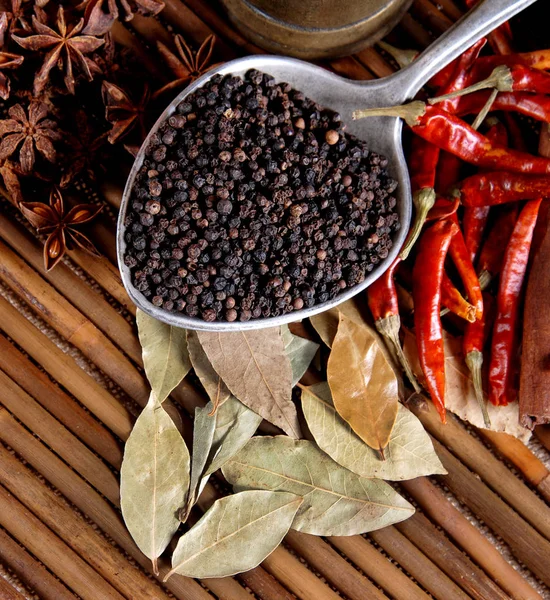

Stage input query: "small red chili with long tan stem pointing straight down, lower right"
[{"left": 462, "top": 294, "right": 495, "bottom": 427}]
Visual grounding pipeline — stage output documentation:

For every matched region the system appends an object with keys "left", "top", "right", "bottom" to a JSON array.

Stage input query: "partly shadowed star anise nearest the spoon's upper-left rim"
[{"left": 101, "top": 81, "right": 149, "bottom": 144}]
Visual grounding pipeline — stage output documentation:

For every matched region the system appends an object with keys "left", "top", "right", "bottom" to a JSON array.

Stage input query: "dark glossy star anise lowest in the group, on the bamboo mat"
[{"left": 19, "top": 188, "right": 103, "bottom": 271}]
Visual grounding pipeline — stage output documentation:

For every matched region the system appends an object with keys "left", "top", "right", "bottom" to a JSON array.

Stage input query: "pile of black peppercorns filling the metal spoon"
[{"left": 124, "top": 71, "right": 399, "bottom": 321}]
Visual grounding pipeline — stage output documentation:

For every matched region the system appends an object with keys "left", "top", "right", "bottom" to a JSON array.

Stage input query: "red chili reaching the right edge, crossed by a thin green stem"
[{"left": 451, "top": 91, "right": 550, "bottom": 123}]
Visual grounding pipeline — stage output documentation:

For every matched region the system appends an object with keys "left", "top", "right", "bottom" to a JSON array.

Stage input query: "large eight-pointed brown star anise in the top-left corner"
[{"left": 12, "top": 6, "right": 104, "bottom": 96}]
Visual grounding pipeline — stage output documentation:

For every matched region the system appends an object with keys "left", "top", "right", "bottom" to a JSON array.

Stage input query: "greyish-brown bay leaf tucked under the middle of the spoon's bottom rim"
[{"left": 198, "top": 327, "right": 301, "bottom": 438}]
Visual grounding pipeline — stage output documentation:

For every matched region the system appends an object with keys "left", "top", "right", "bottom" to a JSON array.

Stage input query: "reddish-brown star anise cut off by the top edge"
[{"left": 79, "top": 0, "right": 164, "bottom": 35}]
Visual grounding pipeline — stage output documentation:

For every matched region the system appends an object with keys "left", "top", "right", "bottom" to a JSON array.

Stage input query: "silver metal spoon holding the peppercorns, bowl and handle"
[{"left": 117, "top": 0, "right": 535, "bottom": 331}]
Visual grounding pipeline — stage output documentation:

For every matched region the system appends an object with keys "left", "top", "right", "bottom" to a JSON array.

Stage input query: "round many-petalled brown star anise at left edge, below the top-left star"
[{"left": 0, "top": 102, "right": 61, "bottom": 174}]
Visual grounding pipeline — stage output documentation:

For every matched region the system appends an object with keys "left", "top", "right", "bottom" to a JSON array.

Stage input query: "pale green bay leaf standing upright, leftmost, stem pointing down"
[{"left": 120, "top": 393, "right": 189, "bottom": 574}]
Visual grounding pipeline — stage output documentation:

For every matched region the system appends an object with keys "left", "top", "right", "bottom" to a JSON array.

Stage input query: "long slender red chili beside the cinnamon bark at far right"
[{"left": 489, "top": 198, "right": 542, "bottom": 406}]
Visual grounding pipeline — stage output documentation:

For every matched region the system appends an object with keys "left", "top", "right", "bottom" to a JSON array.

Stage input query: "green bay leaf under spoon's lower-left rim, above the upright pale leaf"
[{"left": 136, "top": 308, "right": 191, "bottom": 402}]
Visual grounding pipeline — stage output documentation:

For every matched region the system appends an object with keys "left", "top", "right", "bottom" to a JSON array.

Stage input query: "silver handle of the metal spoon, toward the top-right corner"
[{"left": 391, "top": 0, "right": 535, "bottom": 104}]
